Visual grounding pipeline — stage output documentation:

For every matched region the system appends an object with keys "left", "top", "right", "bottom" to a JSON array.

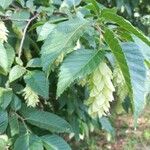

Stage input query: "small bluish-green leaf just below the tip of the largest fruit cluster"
[{"left": 99, "top": 117, "right": 115, "bottom": 136}]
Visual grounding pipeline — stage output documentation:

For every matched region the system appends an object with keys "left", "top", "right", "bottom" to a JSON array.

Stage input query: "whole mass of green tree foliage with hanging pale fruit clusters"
[{"left": 0, "top": 0, "right": 150, "bottom": 150}]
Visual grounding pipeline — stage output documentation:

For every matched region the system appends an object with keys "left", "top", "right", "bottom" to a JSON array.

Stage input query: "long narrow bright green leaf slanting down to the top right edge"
[{"left": 101, "top": 9, "right": 150, "bottom": 46}]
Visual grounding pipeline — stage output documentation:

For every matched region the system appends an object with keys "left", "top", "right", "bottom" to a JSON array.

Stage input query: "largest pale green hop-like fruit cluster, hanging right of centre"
[{"left": 87, "top": 62, "right": 115, "bottom": 118}]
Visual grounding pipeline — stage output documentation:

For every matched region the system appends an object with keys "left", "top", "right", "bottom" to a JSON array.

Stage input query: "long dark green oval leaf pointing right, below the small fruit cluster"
[{"left": 20, "top": 106, "right": 71, "bottom": 133}]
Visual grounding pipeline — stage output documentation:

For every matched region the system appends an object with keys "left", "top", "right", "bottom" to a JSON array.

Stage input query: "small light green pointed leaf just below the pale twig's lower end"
[{"left": 9, "top": 65, "right": 26, "bottom": 83}]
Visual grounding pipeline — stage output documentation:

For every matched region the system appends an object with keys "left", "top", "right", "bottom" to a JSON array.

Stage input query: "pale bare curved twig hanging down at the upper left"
[{"left": 18, "top": 14, "right": 39, "bottom": 58}]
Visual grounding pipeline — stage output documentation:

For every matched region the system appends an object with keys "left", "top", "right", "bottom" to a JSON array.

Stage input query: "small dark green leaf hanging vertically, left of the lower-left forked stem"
[{"left": 9, "top": 114, "right": 19, "bottom": 137}]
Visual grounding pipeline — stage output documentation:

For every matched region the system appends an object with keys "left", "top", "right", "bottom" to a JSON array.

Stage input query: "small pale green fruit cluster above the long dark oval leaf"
[{"left": 23, "top": 86, "right": 39, "bottom": 107}]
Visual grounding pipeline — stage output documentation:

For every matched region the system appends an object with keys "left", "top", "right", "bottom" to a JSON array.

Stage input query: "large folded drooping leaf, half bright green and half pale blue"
[{"left": 104, "top": 29, "right": 146, "bottom": 121}]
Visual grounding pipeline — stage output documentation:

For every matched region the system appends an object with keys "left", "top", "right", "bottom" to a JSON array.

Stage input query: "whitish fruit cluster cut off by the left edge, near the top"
[{"left": 0, "top": 21, "right": 8, "bottom": 43}]
